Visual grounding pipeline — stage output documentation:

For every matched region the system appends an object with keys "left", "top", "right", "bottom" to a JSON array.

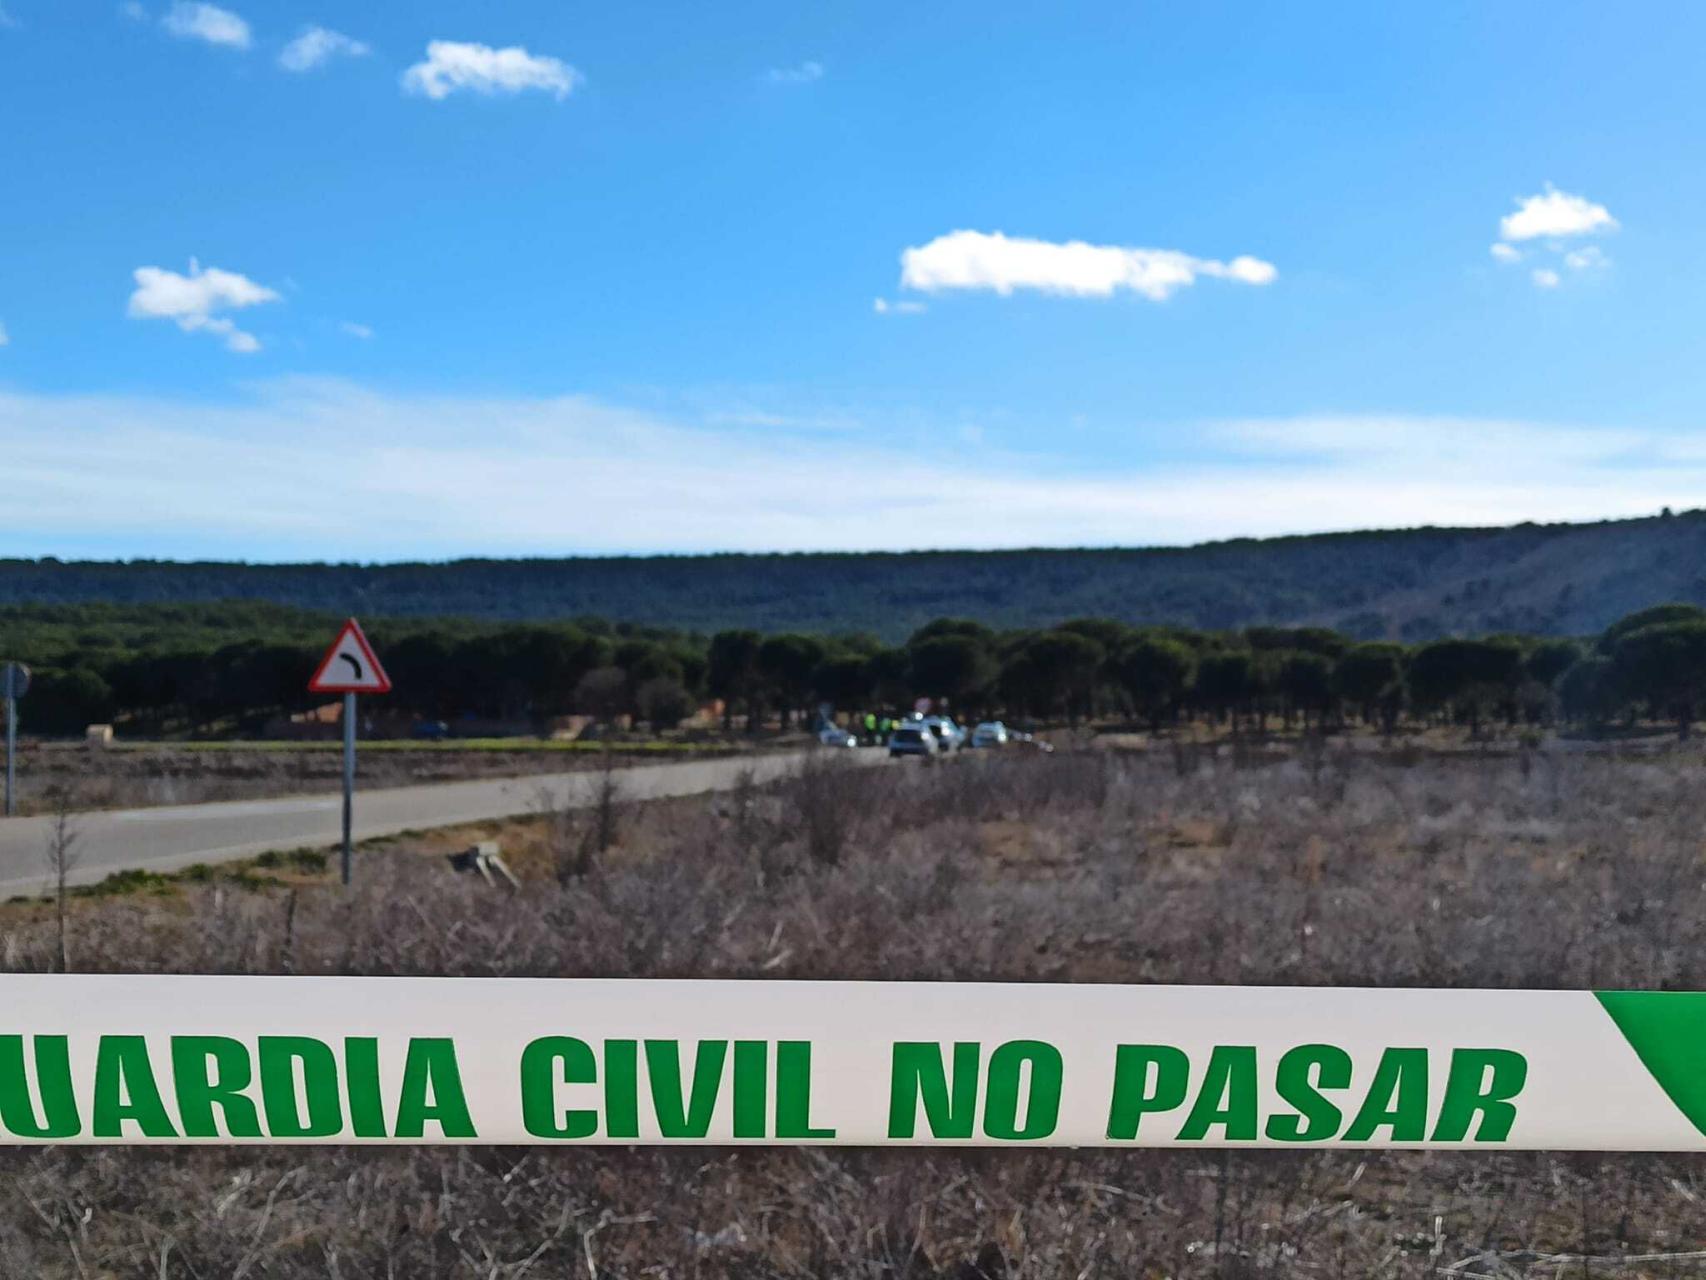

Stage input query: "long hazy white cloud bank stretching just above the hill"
[{"left": 0, "top": 382, "right": 1706, "bottom": 560}]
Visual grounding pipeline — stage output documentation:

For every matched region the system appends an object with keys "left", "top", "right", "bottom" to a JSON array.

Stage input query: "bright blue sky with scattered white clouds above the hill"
[{"left": 0, "top": 0, "right": 1706, "bottom": 560}]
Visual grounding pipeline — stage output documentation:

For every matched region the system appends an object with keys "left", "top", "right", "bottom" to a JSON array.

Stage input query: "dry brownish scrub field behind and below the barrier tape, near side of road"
[{"left": 0, "top": 748, "right": 1706, "bottom": 1280}]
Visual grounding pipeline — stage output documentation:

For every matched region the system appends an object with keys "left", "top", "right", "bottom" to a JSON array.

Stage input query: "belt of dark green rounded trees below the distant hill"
[{"left": 0, "top": 602, "right": 1706, "bottom": 734}]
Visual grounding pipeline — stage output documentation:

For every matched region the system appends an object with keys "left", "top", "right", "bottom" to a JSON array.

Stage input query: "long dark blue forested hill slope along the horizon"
[{"left": 0, "top": 512, "right": 1706, "bottom": 640}]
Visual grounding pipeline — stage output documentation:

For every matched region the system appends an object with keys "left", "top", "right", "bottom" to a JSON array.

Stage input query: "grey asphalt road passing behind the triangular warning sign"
[{"left": 0, "top": 749, "right": 887, "bottom": 898}]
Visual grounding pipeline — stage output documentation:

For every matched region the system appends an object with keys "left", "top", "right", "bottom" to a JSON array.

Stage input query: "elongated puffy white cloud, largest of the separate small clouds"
[{"left": 901, "top": 230, "right": 1278, "bottom": 302}]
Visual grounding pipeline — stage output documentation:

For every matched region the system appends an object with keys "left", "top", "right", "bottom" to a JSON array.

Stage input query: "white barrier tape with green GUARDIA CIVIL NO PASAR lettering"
[{"left": 0, "top": 975, "right": 1706, "bottom": 1150}]
